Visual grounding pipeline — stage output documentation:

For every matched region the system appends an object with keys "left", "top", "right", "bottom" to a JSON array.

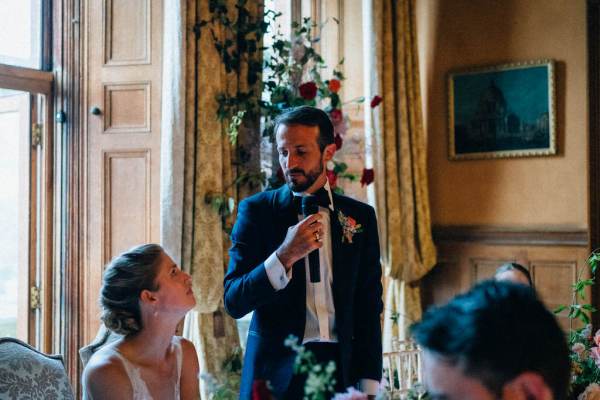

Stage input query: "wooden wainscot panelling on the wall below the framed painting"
[{"left": 421, "top": 227, "right": 589, "bottom": 329}]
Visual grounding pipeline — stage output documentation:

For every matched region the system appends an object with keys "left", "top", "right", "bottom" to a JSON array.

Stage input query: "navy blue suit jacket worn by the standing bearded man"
[{"left": 224, "top": 186, "right": 383, "bottom": 399}]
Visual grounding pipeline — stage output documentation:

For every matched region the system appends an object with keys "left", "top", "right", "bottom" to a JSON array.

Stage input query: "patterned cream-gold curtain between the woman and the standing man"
[{"left": 181, "top": 0, "right": 262, "bottom": 398}]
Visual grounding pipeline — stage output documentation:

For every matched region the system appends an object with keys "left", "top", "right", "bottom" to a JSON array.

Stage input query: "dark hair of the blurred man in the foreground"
[{"left": 411, "top": 280, "right": 570, "bottom": 400}]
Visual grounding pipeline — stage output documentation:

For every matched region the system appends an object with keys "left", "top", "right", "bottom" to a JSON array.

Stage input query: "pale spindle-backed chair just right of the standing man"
[{"left": 383, "top": 340, "right": 422, "bottom": 399}]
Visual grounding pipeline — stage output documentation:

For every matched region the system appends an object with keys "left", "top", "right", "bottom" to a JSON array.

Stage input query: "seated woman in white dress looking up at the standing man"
[{"left": 83, "top": 244, "right": 200, "bottom": 400}]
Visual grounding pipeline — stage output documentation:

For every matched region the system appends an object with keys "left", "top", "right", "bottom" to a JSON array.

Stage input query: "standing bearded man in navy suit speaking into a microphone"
[{"left": 224, "top": 106, "right": 383, "bottom": 399}]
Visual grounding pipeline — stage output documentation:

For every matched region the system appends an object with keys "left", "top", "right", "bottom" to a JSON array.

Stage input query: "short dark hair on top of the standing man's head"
[{"left": 273, "top": 106, "right": 334, "bottom": 151}]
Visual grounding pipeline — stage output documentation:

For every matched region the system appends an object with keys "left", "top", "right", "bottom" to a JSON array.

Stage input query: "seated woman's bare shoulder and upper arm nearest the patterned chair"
[{"left": 82, "top": 349, "right": 133, "bottom": 400}]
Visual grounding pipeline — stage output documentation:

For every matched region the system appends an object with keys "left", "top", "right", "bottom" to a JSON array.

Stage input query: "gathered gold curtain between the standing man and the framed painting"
[{"left": 363, "top": 0, "right": 436, "bottom": 350}]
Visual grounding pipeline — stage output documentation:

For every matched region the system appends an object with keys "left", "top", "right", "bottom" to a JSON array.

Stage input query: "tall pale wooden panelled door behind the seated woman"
[{"left": 83, "top": 0, "right": 162, "bottom": 343}]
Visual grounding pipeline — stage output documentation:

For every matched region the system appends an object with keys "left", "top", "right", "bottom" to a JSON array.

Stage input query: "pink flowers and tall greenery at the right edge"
[{"left": 554, "top": 252, "right": 600, "bottom": 400}]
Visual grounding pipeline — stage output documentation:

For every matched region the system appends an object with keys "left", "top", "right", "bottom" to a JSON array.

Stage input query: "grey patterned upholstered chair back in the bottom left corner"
[{"left": 0, "top": 337, "right": 74, "bottom": 400}]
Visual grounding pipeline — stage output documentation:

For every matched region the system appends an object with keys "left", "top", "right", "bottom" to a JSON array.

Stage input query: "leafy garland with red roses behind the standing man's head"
[{"left": 199, "top": 4, "right": 382, "bottom": 220}]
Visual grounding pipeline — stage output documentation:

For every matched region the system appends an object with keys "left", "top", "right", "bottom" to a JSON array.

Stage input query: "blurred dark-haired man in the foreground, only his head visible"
[{"left": 411, "top": 280, "right": 570, "bottom": 400}]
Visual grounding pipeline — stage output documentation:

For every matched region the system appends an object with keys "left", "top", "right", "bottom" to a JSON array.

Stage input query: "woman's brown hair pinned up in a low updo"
[{"left": 100, "top": 244, "right": 163, "bottom": 336}]
